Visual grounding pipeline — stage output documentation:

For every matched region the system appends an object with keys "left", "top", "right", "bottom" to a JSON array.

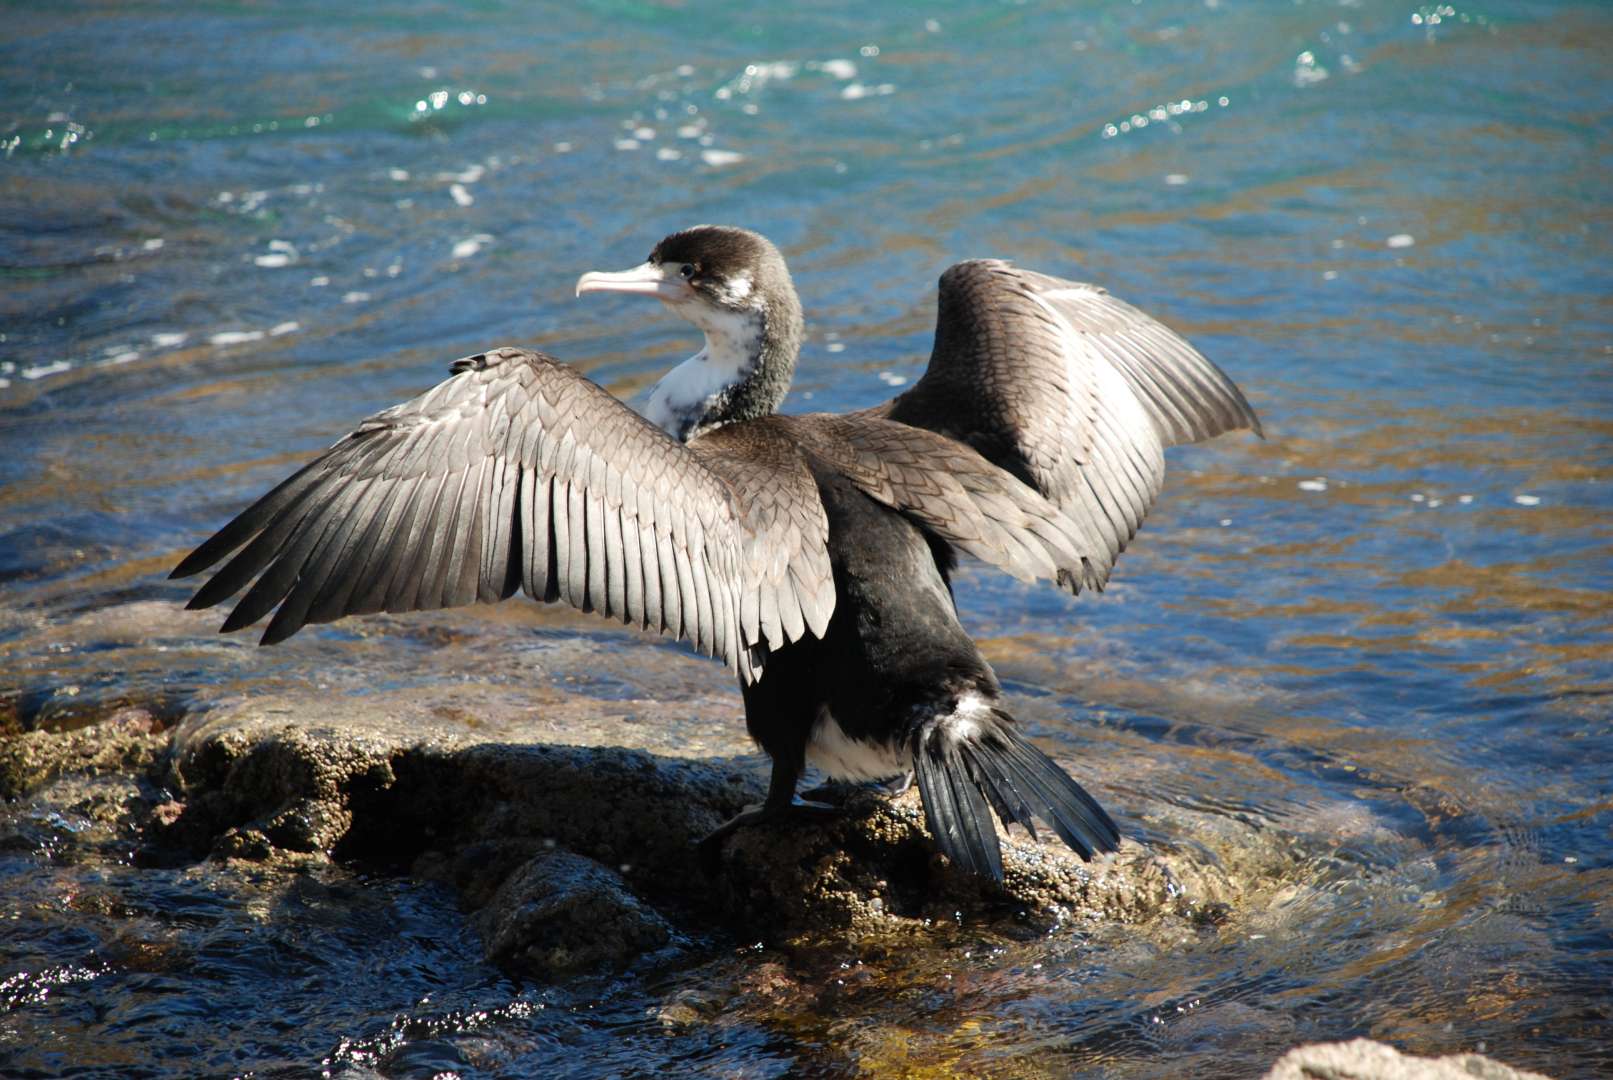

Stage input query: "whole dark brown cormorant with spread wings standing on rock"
[{"left": 174, "top": 226, "right": 1260, "bottom": 879}]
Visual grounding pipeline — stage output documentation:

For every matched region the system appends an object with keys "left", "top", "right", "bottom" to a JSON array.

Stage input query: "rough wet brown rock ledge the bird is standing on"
[{"left": 125, "top": 700, "right": 1264, "bottom": 970}]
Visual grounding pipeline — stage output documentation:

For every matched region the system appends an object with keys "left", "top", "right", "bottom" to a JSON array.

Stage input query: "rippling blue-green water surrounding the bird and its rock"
[{"left": 0, "top": 0, "right": 1613, "bottom": 1077}]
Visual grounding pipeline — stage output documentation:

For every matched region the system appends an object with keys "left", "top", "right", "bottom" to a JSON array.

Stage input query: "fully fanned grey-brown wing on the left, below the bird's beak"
[{"left": 173, "top": 348, "right": 834, "bottom": 677}]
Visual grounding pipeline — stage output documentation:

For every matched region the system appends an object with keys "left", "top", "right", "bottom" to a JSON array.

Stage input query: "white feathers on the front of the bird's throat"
[{"left": 644, "top": 303, "right": 766, "bottom": 442}]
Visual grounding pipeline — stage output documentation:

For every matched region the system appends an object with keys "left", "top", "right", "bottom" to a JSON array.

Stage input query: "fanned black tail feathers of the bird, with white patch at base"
[{"left": 913, "top": 703, "right": 1119, "bottom": 882}]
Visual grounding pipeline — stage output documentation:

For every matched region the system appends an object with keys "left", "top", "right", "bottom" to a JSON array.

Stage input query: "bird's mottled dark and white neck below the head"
[{"left": 644, "top": 293, "right": 800, "bottom": 442}]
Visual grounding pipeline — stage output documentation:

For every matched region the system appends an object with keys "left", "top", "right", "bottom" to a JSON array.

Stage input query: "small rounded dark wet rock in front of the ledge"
[{"left": 476, "top": 851, "right": 673, "bottom": 977}]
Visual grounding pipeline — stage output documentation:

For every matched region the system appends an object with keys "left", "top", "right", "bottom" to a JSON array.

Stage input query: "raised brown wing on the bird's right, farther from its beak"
[{"left": 877, "top": 260, "right": 1260, "bottom": 590}]
